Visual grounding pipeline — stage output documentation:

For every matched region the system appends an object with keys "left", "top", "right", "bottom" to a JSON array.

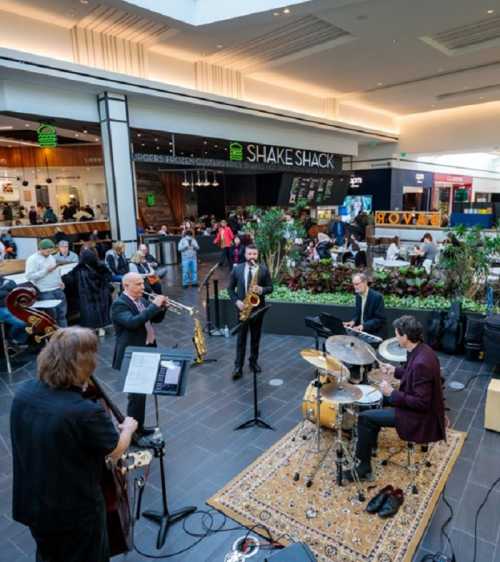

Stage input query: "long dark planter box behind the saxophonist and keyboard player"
[{"left": 211, "top": 300, "right": 432, "bottom": 337}]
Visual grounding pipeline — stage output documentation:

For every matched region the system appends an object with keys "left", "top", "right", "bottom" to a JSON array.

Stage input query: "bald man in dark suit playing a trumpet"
[{"left": 111, "top": 273, "right": 169, "bottom": 447}]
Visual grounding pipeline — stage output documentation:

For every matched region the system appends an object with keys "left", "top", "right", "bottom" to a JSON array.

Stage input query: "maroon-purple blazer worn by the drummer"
[{"left": 391, "top": 343, "right": 446, "bottom": 444}]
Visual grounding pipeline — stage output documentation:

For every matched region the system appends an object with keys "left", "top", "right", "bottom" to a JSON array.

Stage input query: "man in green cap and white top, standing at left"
[{"left": 26, "top": 238, "right": 68, "bottom": 328}]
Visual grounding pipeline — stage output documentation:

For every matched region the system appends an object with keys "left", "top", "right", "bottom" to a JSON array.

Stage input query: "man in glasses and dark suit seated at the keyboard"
[{"left": 344, "top": 273, "right": 386, "bottom": 337}]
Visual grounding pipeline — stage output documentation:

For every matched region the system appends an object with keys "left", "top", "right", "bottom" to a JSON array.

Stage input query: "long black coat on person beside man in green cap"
[{"left": 64, "top": 250, "right": 111, "bottom": 328}]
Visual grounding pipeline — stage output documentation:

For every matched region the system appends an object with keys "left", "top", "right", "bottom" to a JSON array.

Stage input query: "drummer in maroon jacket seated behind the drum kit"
[{"left": 347, "top": 316, "right": 446, "bottom": 480}]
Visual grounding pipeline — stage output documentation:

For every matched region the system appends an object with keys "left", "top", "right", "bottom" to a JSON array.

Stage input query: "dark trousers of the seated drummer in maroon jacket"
[{"left": 356, "top": 397, "right": 396, "bottom": 468}]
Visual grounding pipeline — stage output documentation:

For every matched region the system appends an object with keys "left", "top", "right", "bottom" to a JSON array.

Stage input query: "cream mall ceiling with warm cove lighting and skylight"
[{"left": 0, "top": 0, "right": 500, "bottom": 159}]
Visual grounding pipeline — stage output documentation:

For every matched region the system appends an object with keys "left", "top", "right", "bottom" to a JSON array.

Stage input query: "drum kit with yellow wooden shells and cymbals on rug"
[{"left": 293, "top": 335, "right": 406, "bottom": 494}]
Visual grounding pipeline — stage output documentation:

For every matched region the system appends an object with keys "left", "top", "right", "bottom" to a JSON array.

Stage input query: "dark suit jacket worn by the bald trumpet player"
[{"left": 111, "top": 293, "right": 166, "bottom": 369}]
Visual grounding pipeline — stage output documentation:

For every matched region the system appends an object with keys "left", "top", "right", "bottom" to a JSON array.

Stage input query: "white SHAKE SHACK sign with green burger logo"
[{"left": 229, "top": 142, "right": 341, "bottom": 171}]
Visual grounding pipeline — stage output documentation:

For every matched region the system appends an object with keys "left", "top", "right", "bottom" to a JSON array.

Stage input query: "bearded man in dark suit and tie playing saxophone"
[{"left": 228, "top": 244, "right": 273, "bottom": 380}]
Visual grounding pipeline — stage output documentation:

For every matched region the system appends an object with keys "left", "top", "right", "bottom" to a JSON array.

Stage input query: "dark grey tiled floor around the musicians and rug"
[{"left": 0, "top": 262, "right": 500, "bottom": 562}]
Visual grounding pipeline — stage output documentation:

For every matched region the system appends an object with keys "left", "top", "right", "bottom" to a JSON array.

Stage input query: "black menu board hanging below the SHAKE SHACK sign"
[{"left": 278, "top": 174, "right": 349, "bottom": 207}]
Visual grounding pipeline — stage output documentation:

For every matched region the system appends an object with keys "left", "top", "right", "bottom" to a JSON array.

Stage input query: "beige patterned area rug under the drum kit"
[{"left": 208, "top": 422, "right": 466, "bottom": 562}]
